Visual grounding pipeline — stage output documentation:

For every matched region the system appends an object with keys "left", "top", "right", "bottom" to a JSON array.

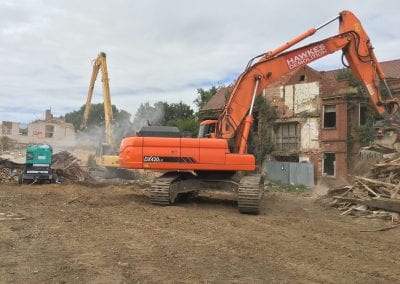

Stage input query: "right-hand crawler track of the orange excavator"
[{"left": 238, "top": 174, "right": 264, "bottom": 214}]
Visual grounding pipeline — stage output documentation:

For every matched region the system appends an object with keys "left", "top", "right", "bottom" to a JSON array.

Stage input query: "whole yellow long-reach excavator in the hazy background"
[{"left": 81, "top": 52, "right": 119, "bottom": 168}]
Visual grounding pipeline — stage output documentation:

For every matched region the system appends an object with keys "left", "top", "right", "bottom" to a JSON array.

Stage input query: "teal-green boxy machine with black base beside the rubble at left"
[{"left": 19, "top": 145, "right": 53, "bottom": 184}]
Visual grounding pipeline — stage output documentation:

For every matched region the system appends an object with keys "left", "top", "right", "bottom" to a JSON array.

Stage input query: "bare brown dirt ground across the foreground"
[{"left": 0, "top": 184, "right": 400, "bottom": 283}]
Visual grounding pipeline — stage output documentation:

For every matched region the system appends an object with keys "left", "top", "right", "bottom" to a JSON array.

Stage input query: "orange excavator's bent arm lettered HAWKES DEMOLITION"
[{"left": 215, "top": 11, "right": 398, "bottom": 154}]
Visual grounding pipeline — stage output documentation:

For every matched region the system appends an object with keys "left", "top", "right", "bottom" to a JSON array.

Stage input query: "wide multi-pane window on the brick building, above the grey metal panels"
[{"left": 276, "top": 123, "right": 299, "bottom": 150}]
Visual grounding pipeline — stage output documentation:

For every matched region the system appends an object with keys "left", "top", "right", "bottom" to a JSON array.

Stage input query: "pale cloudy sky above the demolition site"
[{"left": 0, "top": 0, "right": 400, "bottom": 123}]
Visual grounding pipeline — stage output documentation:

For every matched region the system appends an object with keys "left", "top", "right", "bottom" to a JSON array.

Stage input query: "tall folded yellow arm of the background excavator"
[{"left": 81, "top": 52, "right": 115, "bottom": 149}]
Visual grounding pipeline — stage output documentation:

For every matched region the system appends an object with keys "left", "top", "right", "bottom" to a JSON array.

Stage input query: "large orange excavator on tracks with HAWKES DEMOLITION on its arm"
[{"left": 119, "top": 11, "right": 399, "bottom": 214}]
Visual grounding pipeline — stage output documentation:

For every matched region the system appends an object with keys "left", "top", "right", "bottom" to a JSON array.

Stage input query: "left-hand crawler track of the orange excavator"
[{"left": 150, "top": 175, "right": 177, "bottom": 206}]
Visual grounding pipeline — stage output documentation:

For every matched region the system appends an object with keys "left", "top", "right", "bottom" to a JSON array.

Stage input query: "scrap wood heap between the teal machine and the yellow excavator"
[{"left": 51, "top": 151, "right": 94, "bottom": 182}]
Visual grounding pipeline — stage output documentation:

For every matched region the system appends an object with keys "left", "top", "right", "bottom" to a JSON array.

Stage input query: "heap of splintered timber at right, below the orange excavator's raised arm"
[{"left": 328, "top": 155, "right": 400, "bottom": 222}]
